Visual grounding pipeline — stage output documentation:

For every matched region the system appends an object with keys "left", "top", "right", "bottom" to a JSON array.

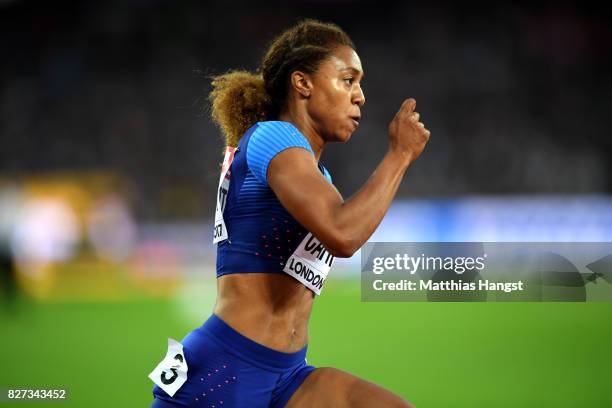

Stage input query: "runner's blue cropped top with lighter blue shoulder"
[{"left": 217, "top": 121, "right": 331, "bottom": 277}]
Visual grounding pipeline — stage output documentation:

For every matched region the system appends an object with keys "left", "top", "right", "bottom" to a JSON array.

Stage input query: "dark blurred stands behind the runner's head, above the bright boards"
[{"left": 0, "top": 0, "right": 612, "bottom": 220}]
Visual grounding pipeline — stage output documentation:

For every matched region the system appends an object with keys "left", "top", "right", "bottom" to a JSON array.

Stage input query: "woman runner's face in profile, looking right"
[{"left": 307, "top": 46, "right": 365, "bottom": 142}]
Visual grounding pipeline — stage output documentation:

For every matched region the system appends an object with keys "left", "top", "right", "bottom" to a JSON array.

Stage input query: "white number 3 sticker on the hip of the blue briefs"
[{"left": 149, "top": 339, "right": 187, "bottom": 397}]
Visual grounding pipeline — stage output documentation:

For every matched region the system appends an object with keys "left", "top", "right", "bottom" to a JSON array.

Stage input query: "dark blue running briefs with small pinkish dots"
[{"left": 151, "top": 314, "right": 315, "bottom": 408}]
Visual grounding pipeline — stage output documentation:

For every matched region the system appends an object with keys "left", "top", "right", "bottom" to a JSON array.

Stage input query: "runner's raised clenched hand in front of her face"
[{"left": 389, "top": 98, "right": 429, "bottom": 163}]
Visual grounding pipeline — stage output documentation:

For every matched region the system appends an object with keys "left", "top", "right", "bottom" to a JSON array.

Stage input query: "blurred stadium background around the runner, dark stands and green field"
[{"left": 0, "top": 0, "right": 612, "bottom": 407}]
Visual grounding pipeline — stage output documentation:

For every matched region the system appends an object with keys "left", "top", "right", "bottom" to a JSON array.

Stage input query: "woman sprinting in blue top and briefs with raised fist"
[{"left": 151, "top": 20, "right": 429, "bottom": 408}]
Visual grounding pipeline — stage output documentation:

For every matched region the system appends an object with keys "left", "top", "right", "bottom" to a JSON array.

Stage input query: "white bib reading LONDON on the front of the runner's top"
[{"left": 283, "top": 232, "right": 334, "bottom": 295}]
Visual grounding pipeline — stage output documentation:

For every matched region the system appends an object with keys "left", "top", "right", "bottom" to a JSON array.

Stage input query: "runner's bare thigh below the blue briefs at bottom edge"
[{"left": 286, "top": 367, "right": 412, "bottom": 408}]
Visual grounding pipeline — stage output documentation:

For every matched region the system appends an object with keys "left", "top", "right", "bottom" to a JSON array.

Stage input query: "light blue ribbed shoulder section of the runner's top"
[{"left": 246, "top": 121, "right": 314, "bottom": 185}]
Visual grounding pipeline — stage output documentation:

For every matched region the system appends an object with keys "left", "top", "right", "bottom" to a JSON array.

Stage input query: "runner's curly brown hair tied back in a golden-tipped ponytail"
[{"left": 209, "top": 19, "right": 355, "bottom": 147}]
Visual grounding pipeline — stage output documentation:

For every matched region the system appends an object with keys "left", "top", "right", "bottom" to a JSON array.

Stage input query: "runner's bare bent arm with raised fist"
[{"left": 267, "top": 99, "right": 429, "bottom": 257}]
